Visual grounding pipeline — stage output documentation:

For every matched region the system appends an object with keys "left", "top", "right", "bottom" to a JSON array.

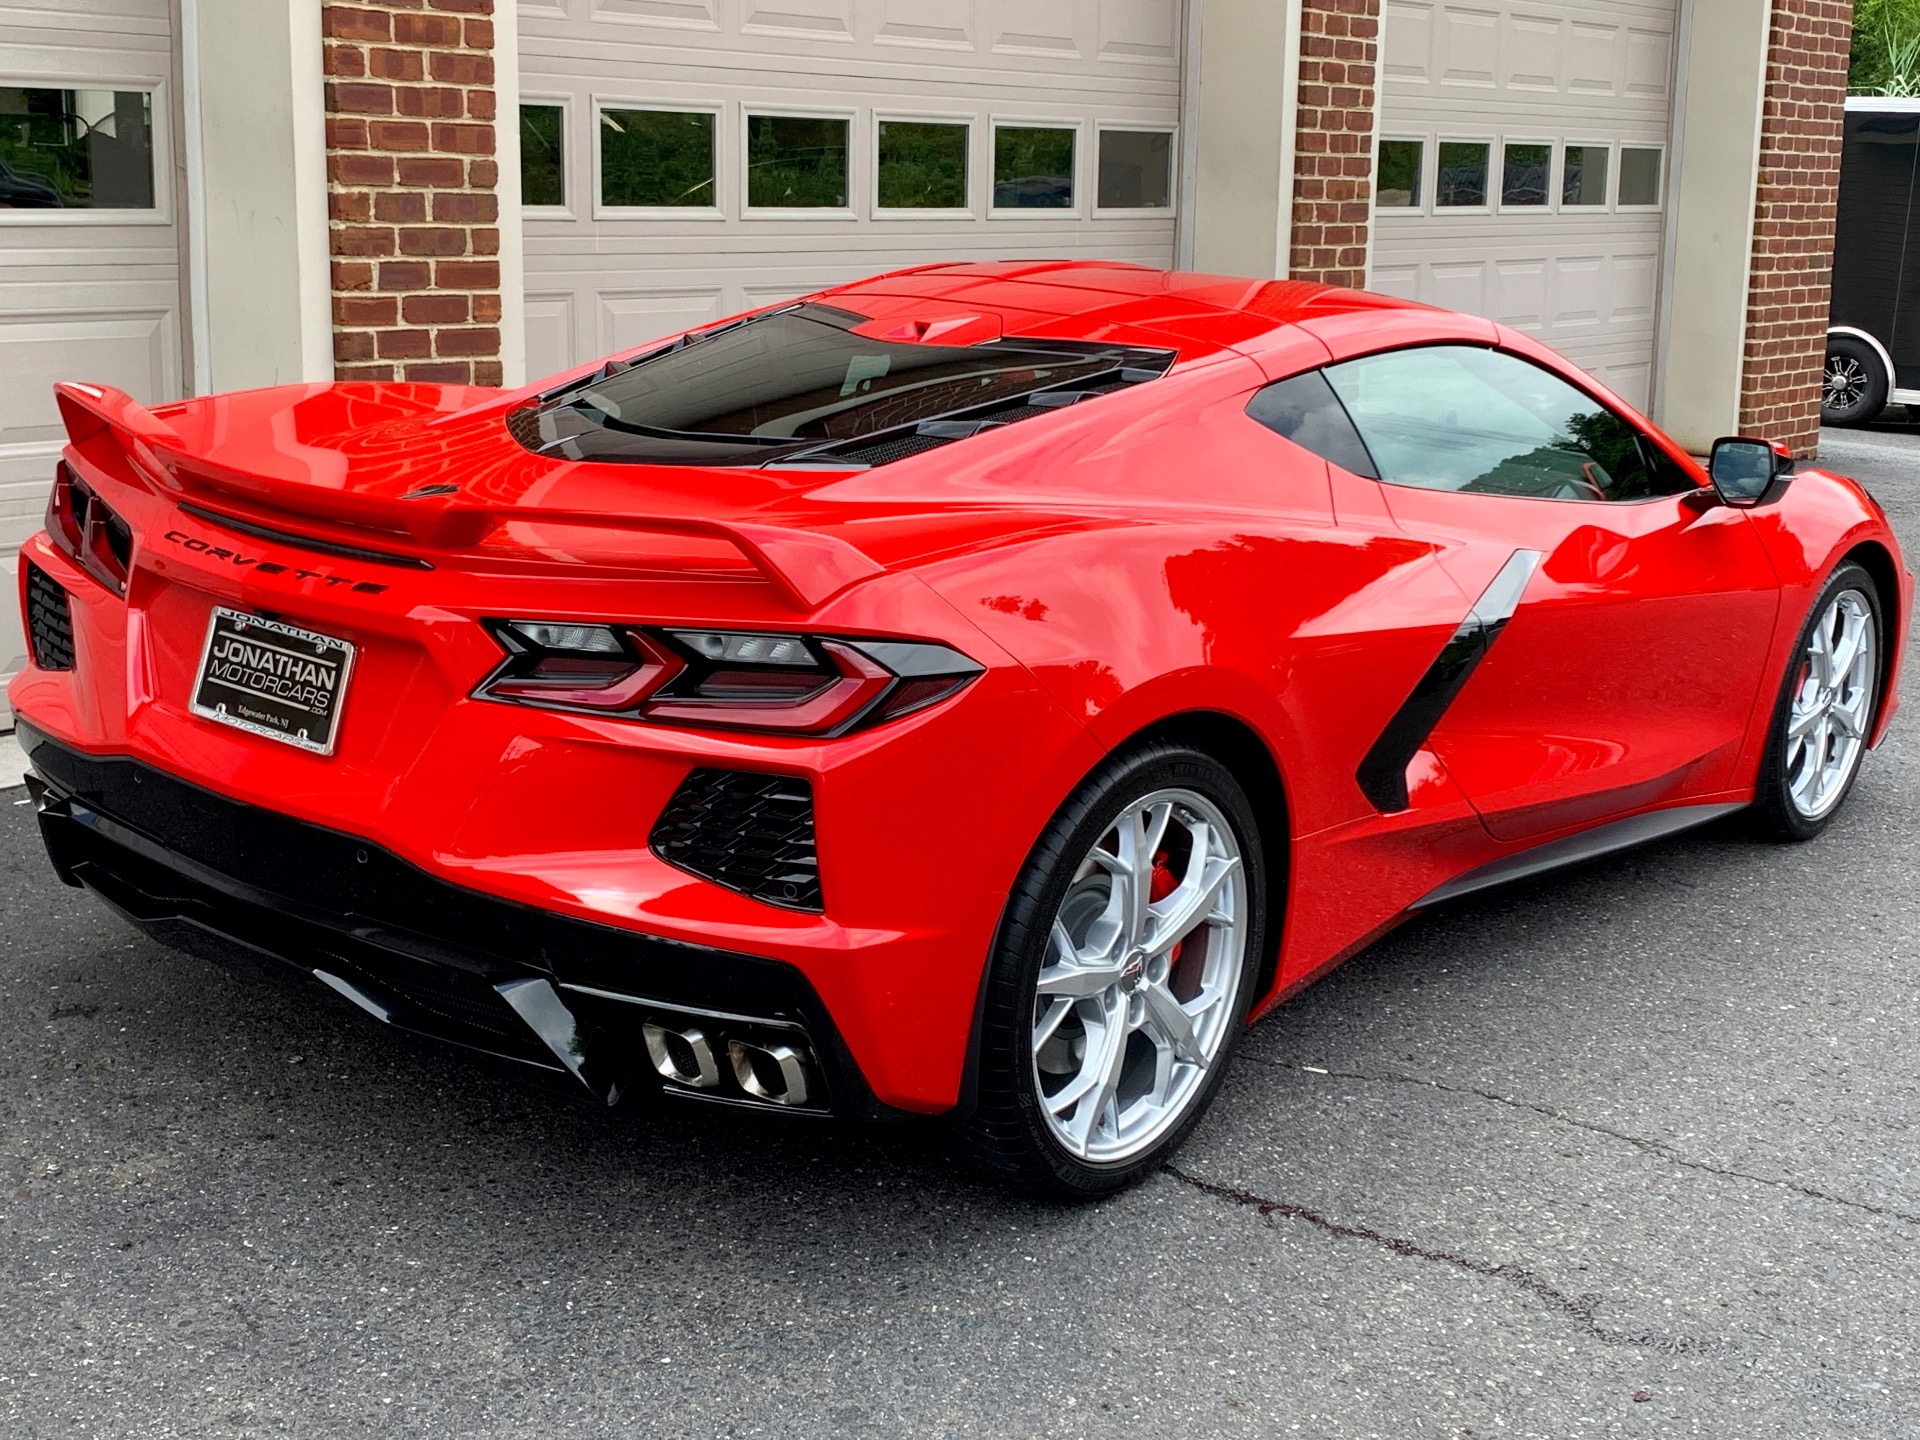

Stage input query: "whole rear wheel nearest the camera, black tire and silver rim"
[{"left": 966, "top": 741, "right": 1267, "bottom": 1200}]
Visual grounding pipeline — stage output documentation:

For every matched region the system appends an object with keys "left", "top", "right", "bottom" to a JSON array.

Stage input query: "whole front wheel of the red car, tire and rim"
[{"left": 1753, "top": 561, "right": 1885, "bottom": 841}]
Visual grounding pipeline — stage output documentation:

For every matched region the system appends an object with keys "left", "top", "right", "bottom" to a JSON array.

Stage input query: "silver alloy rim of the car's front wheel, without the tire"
[{"left": 1786, "top": 589, "right": 1880, "bottom": 820}]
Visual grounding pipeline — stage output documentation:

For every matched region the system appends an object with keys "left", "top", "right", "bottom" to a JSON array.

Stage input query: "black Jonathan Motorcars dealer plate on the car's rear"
[{"left": 192, "top": 607, "right": 353, "bottom": 755}]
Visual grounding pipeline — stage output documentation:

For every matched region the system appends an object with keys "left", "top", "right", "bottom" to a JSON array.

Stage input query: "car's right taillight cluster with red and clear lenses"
[{"left": 476, "top": 620, "right": 981, "bottom": 735}]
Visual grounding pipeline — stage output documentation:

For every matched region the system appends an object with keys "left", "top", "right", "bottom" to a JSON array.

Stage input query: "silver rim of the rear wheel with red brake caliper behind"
[{"left": 1033, "top": 789, "right": 1248, "bottom": 1164}]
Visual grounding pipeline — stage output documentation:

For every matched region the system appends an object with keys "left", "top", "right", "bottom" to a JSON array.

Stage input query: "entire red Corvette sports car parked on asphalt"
[{"left": 12, "top": 263, "right": 1912, "bottom": 1194}]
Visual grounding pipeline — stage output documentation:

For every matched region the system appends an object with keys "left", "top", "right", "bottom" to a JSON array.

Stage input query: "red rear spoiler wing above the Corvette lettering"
[{"left": 54, "top": 380, "right": 885, "bottom": 611}]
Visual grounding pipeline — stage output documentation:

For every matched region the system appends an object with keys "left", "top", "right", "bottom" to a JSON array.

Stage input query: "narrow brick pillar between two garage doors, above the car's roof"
[{"left": 1288, "top": 0, "right": 1380, "bottom": 286}]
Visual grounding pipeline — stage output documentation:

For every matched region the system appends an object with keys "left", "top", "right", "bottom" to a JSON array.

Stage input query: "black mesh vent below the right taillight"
[{"left": 649, "top": 770, "right": 822, "bottom": 910}]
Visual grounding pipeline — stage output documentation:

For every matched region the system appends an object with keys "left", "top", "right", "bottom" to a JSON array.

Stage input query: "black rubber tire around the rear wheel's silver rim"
[{"left": 972, "top": 743, "right": 1267, "bottom": 1200}]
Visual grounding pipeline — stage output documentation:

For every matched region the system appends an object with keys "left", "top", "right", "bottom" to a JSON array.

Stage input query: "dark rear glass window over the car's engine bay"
[{"left": 518, "top": 305, "right": 1171, "bottom": 465}]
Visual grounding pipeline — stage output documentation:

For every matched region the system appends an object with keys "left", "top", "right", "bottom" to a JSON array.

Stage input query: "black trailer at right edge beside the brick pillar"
[{"left": 1820, "top": 96, "right": 1920, "bottom": 424}]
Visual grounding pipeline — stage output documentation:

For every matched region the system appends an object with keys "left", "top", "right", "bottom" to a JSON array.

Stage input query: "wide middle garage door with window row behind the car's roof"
[{"left": 520, "top": 0, "right": 1181, "bottom": 376}]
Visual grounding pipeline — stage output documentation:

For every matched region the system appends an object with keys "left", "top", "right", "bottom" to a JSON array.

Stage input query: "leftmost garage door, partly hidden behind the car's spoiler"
[{"left": 0, "top": 0, "right": 182, "bottom": 728}]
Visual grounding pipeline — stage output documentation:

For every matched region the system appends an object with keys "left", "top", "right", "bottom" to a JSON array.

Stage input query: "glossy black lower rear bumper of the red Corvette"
[{"left": 19, "top": 722, "right": 902, "bottom": 1119}]
